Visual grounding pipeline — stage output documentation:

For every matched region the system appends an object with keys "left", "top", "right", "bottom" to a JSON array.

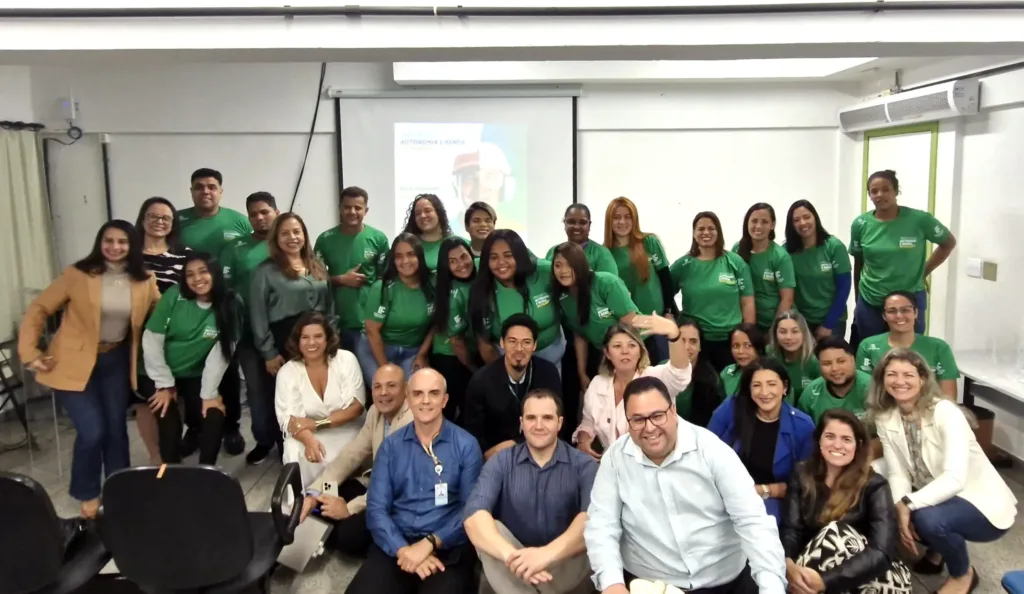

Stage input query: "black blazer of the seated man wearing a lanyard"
[{"left": 462, "top": 356, "right": 562, "bottom": 452}]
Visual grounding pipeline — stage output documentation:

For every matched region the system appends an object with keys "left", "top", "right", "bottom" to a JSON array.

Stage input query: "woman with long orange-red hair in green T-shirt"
[{"left": 604, "top": 196, "right": 679, "bottom": 363}]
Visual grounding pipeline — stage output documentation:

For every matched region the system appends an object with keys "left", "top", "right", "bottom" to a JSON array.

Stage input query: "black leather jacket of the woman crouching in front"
[{"left": 780, "top": 465, "right": 899, "bottom": 593}]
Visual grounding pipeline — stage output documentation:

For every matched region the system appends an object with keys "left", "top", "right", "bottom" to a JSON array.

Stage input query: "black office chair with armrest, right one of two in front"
[{"left": 96, "top": 463, "right": 302, "bottom": 594}]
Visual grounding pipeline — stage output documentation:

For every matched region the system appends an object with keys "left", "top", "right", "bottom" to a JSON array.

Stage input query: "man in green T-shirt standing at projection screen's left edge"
[{"left": 313, "top": 185, "right": 391, "bottom": 352}]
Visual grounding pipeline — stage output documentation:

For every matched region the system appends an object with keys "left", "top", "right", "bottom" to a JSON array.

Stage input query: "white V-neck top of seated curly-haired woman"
[{"left": 274, "top": 350, "right": 366, "bottom": 435}]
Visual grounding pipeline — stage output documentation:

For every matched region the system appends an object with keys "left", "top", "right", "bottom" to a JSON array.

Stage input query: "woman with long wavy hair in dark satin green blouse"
[{"left": 248, "top": 212, "right": 335, "bottom": 376}]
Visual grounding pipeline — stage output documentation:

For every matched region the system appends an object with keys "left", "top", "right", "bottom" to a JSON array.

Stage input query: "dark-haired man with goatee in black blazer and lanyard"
[{"left": 463, "top": 313, "right": 562, "bottom": 460}]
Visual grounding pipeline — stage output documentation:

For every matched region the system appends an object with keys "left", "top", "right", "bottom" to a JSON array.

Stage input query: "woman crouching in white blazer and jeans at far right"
[{"left": 867, "top": 348, "right": 1017, "bottom": 594}]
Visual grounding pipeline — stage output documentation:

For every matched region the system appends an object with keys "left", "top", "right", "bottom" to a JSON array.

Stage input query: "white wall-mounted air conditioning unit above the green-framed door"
[{"left": 839, "top": 79, "right": 980, "bottom": 132}]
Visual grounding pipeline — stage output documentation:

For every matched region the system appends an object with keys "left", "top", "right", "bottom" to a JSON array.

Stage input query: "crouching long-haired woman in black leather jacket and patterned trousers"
[{"left": 779, "top": 409, "right": 912, "bottom": 594}]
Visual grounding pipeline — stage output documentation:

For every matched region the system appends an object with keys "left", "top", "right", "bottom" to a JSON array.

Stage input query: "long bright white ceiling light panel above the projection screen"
[{"left": 394, "top": 57, "right": 877, "bottom": 84}]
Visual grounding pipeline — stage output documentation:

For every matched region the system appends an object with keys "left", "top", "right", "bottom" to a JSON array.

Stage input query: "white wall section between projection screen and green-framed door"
[{"left": 579, "top": 83, "right": 854, "bottom": 259}]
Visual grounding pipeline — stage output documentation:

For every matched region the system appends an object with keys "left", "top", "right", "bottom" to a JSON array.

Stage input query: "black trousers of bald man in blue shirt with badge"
[{"left": 345, "top": 544, "right": 476, "bottom": 594}]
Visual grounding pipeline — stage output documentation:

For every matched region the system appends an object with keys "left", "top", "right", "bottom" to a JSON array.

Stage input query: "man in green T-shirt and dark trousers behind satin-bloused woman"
[{"left": 221, "top": 192, "right": 282, "bottom": 464}]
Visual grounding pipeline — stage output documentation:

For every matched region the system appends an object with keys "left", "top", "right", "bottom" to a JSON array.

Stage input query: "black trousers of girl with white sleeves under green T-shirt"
[{"left": 157, "top": 378, "right": 224, "bottom": 466}]
